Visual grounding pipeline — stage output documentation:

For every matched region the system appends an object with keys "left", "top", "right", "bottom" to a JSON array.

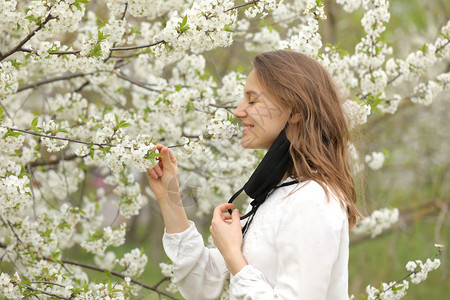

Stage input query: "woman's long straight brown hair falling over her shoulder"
[{"left": 253, "top": 50, "right": 361, "bottom": 228}]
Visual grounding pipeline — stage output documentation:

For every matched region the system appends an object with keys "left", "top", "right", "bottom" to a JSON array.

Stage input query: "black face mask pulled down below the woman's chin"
[{"left": 228, "top": 124, "right": 298, "bottom": 235}]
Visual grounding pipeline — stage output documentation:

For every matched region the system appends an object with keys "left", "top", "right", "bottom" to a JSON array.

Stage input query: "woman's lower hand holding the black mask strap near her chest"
[{"left": 209, "top": 203, "right": 247, "bottom": 275}]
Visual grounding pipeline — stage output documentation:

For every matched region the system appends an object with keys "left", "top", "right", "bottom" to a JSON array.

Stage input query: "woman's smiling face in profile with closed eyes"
[{"left": 234, "top": 70, "right": 291, "bottom": 149}]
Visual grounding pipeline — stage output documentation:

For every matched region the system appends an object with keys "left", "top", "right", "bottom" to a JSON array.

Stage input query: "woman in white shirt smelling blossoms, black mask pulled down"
[{"left": 148, "top": 51, "right": 360, "bottom": 300}]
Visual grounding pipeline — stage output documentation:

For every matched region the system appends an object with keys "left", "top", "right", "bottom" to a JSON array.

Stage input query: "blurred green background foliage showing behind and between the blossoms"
[{"left": 54, "top": 0, "right": 450, "bottom": 299}]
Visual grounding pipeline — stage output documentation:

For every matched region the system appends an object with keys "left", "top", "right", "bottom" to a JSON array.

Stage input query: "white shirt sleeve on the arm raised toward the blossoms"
[{"left": 163, "top": 221, "right": 229, "bottom": 300}]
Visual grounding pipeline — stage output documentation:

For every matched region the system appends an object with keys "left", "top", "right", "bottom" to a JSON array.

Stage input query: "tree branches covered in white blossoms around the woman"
[{"left": 0, "top": 0, "right": 450, "bottom": 299}]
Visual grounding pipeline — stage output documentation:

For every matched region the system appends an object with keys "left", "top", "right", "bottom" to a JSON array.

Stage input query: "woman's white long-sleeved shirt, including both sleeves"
[{"left": 163, "top": 179, "right": 349, "bottom": 300}]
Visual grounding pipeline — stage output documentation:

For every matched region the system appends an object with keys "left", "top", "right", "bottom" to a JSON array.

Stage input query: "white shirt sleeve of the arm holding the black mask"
[{"left": 230, "top": 186, "right": 346, "bottom": 300}]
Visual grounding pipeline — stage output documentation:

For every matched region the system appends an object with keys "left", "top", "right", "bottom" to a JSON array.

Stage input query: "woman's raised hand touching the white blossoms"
[{"left": 147, "top": 144, "right": 179, "bottom": 200}]
